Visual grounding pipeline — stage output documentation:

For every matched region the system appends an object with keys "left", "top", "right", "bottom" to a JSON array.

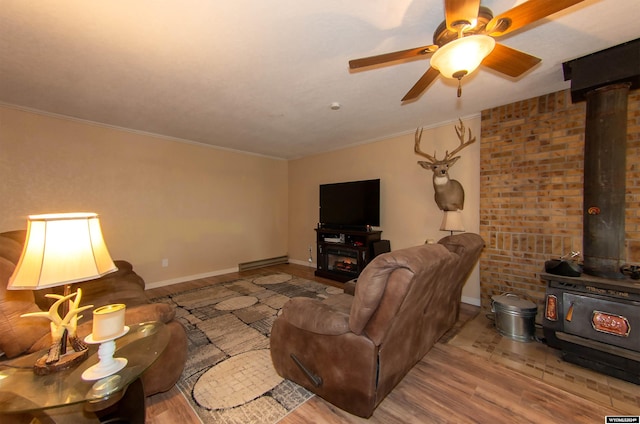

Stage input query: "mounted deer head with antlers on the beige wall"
[{"left": 414, "top": 119, "right": 476, "bottom": 211}]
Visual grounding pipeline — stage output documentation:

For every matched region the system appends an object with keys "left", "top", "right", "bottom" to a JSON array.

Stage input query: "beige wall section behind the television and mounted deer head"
[{"left": 289, "top": 116, "right": 480, "bottom": 305}]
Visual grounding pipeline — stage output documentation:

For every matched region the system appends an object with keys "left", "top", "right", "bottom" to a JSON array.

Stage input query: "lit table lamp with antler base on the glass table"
[{"left": 7, "top": 213, "right": 117, "bottom": 374}]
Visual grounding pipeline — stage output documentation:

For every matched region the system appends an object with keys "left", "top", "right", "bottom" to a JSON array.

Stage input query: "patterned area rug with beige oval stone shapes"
[{"left": 153, "top": 273, "right": 343, "bottom": 424}]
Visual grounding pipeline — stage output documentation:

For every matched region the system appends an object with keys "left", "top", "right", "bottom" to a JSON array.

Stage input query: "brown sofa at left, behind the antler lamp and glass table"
[{"left": 0, "top": 230, "right": 187, "bottom": 396}]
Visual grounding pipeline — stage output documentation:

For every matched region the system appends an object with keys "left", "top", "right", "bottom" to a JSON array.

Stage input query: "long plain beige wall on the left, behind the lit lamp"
[{"left": 0, "top": 107, "right": 288, "bottom": 284}]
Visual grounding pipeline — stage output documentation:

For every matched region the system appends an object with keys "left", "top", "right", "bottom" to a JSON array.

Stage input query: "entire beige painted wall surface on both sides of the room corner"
[{"left": 0, "top": 103, "right": 480, "bottom": 304}]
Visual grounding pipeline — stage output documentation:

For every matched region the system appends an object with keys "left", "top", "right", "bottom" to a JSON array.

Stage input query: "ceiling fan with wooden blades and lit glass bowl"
[{"left": 349, "top": 0, "right": 583, "bottom": 101}]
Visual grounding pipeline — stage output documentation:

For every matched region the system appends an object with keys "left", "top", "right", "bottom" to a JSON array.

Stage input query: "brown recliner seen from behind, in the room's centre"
[{"left": 271, "top": 233, "right": 484, "bottom": 418}]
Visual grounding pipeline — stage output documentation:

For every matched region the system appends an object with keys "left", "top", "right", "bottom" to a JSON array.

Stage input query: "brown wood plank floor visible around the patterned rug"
[{"left": 142, "top": 264, "right": 628, "bottom": 424}]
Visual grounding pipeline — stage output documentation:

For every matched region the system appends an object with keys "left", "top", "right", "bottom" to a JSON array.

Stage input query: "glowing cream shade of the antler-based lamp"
[{"left": 7, "top": 213, "right": 117, "bottom": 290}]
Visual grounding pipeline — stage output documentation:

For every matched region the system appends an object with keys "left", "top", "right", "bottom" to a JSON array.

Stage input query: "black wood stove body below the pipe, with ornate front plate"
[{"left": 541, "top": 274, "right": 640, "bottom": 384}]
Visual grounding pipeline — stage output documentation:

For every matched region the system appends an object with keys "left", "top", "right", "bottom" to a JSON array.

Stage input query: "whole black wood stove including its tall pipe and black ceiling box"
[{"left": 541, "top": 39, "right": 640, "bottom": 384}]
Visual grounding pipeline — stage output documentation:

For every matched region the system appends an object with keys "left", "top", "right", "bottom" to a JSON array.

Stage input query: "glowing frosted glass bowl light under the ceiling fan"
[{"left": 431, "top": 35, "right": 496, "bottom": 80}]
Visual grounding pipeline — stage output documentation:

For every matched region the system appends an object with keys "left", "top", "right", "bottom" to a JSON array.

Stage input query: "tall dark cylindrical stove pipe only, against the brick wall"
[{"left": 583, "top": 83, "right": 631, "bottom": 279}]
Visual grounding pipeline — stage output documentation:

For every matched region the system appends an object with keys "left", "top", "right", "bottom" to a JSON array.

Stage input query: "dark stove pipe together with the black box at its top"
[{"left": 562, "top": 38, "right": 640, "bottom": 279}]
